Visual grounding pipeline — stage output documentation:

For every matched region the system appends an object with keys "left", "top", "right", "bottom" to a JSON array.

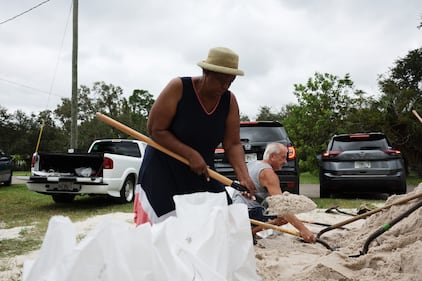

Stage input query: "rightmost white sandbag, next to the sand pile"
[{"left": 174, "top": 192, "right": 260, "bottom": 281}]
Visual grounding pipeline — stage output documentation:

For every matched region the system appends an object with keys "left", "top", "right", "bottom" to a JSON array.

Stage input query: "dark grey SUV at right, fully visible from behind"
[{"left": 319, "top": 133, "right": 406, "bottom": 197}]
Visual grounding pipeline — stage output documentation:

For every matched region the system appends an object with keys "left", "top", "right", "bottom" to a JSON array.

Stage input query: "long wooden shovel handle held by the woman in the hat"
[{"left": 95, "top": 112, "right": 248, "bottom": 191}]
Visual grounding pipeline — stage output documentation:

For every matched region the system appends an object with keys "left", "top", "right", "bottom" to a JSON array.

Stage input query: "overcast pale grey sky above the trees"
[{"left": 0, "top": 0, "right": 422, "bottom": 119}]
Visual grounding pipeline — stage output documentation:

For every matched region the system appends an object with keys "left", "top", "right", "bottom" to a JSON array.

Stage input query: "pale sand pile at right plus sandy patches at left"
[{"left": 0, "top": 184, "right": 422, "bottom": 281}]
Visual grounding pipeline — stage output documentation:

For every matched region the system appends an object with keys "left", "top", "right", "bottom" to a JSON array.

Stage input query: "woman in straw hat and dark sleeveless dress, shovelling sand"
[{"left": 135, "top": 47, "right": 255, "bottom": 224}]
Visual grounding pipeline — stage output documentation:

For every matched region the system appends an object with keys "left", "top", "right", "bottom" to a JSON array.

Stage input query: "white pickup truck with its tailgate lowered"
[{"left": 25, "top": 139, "right": 146, "bottom": 203}]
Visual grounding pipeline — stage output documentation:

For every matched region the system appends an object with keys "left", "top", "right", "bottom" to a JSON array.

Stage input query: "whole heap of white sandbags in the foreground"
[{"left": 23, "top": 192, "right": 261, "bottom": 281}]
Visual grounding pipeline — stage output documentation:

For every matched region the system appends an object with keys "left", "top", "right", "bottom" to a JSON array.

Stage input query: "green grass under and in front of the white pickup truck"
[{"left": 0, "top": 184, "right": 133, "bottom": 258}]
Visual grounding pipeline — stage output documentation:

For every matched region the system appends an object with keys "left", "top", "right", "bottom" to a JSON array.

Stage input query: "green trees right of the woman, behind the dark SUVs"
[{"left": 257, "top": 48, "right": 422, "bottom": 176}]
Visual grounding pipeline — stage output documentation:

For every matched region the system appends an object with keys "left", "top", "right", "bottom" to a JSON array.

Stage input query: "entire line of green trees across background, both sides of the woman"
[{"left": 0, "top": 48, "right": 422, "bottom": 176}]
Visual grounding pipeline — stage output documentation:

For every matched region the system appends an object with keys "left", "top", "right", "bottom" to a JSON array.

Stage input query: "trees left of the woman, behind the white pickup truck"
[{"left": 0, "top": 82, "right": 154, "bottom": 169}]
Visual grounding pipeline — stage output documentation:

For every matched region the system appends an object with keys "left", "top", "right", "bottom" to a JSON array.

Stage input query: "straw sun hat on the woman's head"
[{"left": 198, "top": 47, "right": 244, "bottom": 76}]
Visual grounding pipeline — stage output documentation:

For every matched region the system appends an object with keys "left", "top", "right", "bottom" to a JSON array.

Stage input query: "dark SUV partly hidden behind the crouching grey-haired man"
[{"left": 214, "top": 121, "right": 299, "bottom": 194}]
